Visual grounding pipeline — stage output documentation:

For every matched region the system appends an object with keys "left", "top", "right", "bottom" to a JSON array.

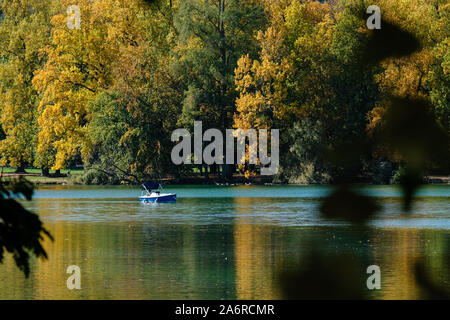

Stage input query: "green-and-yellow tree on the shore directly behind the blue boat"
[{"left": 82, "top": 1, "right": 182, "bottom": 182}]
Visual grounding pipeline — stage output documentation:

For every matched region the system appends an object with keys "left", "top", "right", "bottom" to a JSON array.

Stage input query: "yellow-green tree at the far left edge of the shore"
[{"left": 0, "top": 0, "right": 52, "bottom": 171}]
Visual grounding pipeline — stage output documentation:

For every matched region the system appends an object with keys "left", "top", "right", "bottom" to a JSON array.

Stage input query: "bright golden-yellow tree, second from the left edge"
[{"left": 33, "top": 0, "right": 149, "bottom": 169}]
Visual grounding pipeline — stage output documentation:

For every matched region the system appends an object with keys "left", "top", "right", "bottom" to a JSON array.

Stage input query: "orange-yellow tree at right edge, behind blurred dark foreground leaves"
[{"left": 367, "top": 0, "right": 450, "bottom": 172}]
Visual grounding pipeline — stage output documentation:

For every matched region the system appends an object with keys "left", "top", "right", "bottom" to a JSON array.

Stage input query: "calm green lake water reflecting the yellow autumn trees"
[{"left": 0, "top": 185, "right": 450, "bottom": 299}]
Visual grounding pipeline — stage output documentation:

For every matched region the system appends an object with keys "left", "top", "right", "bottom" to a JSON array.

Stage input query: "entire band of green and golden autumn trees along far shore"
[{"left": 0, "top": 0, "right": 450, "bottom": 184}]
